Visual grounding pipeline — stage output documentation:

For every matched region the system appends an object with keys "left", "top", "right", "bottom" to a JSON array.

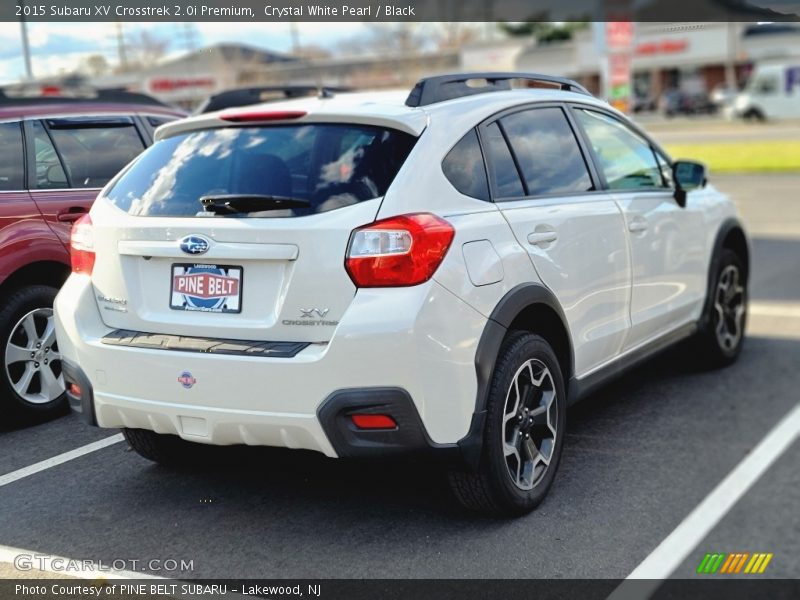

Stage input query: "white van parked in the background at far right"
[{"left": 726, "top": 58, "right": 800, "bottom": 121}]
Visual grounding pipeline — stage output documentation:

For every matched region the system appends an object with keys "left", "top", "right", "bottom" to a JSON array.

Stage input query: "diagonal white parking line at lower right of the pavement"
[{"left": 609, "top": 404, "right": 800, "bottom": 598}]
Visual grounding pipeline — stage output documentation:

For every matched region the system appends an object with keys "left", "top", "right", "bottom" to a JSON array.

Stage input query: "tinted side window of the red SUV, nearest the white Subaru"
[{"left": 35, "top": 117, "right": 145, "bottom": 188}]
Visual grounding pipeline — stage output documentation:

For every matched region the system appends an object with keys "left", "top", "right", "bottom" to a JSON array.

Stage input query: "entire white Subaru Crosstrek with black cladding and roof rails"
[{"left": 55, "top": 73, "right": 749, "bottom": 514}]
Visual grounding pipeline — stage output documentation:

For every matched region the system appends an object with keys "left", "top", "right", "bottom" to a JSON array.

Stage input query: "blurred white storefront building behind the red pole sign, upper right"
[{"left": 460, "top": 22, "right": 800, "bottom": 108}]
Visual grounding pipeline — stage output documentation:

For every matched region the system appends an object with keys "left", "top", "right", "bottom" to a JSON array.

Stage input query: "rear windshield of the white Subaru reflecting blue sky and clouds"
[{"left": 106, "top": 124, "right": 416, "bottom": 217}]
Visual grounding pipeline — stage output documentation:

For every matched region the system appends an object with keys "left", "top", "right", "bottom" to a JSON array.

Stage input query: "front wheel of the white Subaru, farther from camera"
[{"left": 694, "top": 248, "right": 747, "bottom": 369}]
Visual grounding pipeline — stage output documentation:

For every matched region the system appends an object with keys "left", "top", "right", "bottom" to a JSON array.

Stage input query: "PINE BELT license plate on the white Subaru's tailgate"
[{"left": 169, "top": 264, "right": 244, "bottom": 313}]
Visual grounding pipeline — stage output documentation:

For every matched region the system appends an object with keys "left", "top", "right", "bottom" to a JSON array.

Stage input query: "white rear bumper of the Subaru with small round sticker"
[{"left": 55, "top": 276, "right": 486, "bottom": 456}]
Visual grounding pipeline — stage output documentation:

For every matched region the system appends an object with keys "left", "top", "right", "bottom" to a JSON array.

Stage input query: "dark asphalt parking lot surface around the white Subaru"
[{"left": 0, "top": 175, "right": 800, "bottom": 578}]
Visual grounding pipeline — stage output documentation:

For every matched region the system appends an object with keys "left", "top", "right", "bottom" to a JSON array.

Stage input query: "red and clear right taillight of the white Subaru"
[{"left": 345, "top": 213, "right": 455, "bottom": 287}]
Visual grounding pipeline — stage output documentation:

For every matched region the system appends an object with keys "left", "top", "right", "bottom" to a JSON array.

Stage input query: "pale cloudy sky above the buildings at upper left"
[{"left": 0, "top": 22, "right": 364, "bottom": 84}]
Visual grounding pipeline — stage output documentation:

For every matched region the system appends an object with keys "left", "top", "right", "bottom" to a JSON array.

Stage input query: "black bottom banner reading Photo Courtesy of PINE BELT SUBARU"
[{"left": 0, "top": 577, "right": 800, "bottom": 600}]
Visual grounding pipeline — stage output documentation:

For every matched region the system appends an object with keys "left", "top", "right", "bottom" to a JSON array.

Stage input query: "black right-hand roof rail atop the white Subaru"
[{"left": 406, "top": 72, "right": 592, "bottom": 106}]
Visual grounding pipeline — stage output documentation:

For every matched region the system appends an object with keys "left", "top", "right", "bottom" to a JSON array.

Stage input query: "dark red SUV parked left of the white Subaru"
[{"left": 0, "top": 90, "right": 183, "bottom": 421}]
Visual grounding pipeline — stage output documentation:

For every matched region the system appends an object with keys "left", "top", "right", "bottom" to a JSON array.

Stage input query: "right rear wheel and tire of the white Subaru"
[{"left": 449, "top": 331, "right": 567, "bottom": 516}]
